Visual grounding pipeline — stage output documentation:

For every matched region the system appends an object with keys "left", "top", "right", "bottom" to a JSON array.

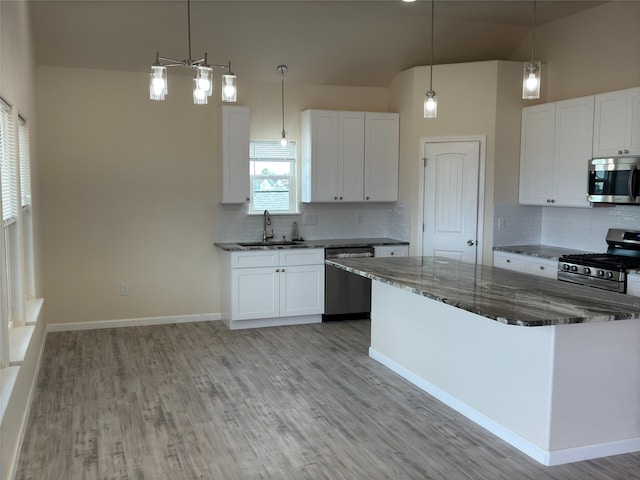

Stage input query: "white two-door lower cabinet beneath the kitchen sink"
[{"left": 221, "top": 249, "right": 324, "bottom": 329}]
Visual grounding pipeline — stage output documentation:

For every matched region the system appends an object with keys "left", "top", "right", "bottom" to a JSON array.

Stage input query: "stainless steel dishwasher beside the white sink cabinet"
[{"left": 322, "top": 247, "right": 374, "bottom": 322}]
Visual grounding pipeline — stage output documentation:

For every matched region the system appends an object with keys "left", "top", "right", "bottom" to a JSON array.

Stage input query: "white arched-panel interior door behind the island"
[{"left": 422, "top": 141, "right": 480, "bottom": 263}]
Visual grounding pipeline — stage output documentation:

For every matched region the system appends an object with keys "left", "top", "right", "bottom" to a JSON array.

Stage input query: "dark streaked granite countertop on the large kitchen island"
[{"left": 326, "top": 257, "right": 640, "bottom": 327}]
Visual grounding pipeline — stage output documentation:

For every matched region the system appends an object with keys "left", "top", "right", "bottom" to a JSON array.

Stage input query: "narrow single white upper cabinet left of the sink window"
[{"left": 220, "top": 105, "right": 250, "bottom": 203}]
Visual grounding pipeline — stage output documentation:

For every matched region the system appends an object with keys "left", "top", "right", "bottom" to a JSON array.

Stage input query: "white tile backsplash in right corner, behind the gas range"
[{"left": 494, "top": 204, "right": 640, "bottom": 252}]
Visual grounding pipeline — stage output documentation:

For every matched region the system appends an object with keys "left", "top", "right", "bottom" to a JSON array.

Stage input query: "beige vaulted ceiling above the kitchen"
[{"left": 29, "top": 0, "right": 605, "bottom": 87}]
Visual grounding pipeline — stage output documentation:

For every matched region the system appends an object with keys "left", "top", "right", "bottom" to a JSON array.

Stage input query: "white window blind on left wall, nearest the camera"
[{"left": 0, "top": 99, "right": 18, "bottom": 226}]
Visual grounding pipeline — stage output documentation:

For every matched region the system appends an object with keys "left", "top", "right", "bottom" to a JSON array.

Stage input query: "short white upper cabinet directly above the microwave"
[{"left": 593, "top": 87, "right": 640, "bottom": 157}]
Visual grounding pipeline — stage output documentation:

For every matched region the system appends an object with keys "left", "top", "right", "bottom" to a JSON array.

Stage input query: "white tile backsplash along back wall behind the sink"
[{"left": 215, "top": 202, "right": 411, "bottom": 242}]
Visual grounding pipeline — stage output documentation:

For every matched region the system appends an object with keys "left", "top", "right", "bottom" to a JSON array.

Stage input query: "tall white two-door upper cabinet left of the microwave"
[{"left": 520, "top": 97, "right": 594, "bottom": 207}]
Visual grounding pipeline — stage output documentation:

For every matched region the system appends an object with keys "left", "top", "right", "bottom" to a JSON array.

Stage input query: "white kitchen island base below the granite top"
[{"left": 369, "top": 280, "right": 640, "bottom": 465}]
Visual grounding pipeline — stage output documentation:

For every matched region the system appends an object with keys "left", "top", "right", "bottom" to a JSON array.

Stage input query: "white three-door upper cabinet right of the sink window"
[{"left": 302, "top": 110, "right": 399, "bottom": 202}]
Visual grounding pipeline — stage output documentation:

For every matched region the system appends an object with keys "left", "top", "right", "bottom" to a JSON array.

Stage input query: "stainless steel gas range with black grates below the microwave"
[{"left": 558, "top": 228, "right": 640, "bottom": 293}]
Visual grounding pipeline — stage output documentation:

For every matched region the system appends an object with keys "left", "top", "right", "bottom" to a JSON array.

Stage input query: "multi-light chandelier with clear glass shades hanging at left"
[{"left": 149, "top": 0, "right": 237, "bottom": 105}]
